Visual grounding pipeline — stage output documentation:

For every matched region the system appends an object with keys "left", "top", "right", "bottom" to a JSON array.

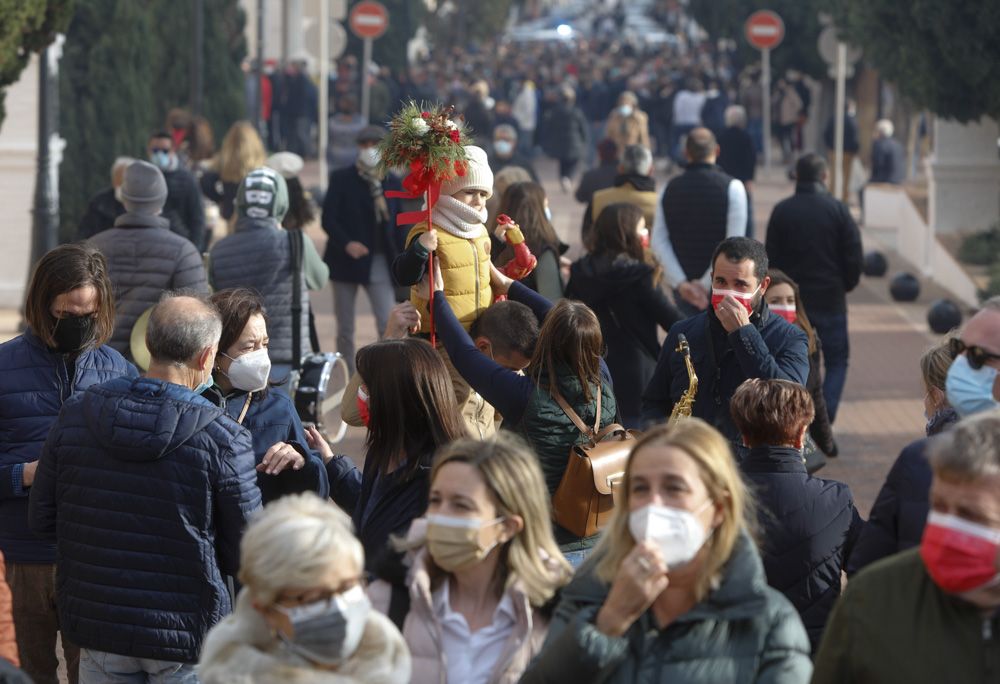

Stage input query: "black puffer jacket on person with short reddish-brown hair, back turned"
[{"left": 740, "top": 447, "right": 864, "bottom": 650}]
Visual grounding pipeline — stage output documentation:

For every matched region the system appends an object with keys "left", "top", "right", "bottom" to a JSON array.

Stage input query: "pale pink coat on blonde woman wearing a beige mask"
[{"left": 368, "top": 536, "right": 549, "bottom": 684}]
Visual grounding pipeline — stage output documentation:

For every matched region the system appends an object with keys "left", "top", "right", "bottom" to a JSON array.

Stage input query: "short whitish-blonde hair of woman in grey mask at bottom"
[{"left": 239, "top": 492, "right": 364, "bottom": 605}]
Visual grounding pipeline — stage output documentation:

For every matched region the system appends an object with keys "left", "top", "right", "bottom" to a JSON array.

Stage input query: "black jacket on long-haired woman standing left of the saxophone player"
[{"left": 566, "top": 254, "right": 681, "bottom": 428}]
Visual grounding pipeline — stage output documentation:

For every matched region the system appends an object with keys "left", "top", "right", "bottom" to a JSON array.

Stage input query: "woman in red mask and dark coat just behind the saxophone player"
[{"left": 764, "top": 268, "right": 838, "bottom": 460}]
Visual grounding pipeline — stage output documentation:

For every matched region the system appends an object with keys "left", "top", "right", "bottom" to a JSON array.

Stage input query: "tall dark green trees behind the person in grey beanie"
[{"left": 59, "top": 0, "right": 246, "bottom": 240}]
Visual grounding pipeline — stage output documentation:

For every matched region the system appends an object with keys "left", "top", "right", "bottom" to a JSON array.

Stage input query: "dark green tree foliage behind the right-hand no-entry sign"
[{"left": 689, "top": 0, "right": 828, "bottom": 78}]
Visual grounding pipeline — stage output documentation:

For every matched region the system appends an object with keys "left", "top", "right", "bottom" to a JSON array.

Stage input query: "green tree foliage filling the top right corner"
[{"left": 834, "top": 0, "right": 1000, "bottom": 123}]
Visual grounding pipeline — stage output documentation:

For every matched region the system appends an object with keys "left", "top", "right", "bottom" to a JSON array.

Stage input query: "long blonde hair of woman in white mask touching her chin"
[{"left": 594, "top": 418, "right": 756, "bottom": 601}]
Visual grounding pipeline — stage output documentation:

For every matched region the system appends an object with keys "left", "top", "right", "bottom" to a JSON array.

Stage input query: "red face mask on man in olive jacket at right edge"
[{"left": 920, "top": 511, "right": 1000, "bottom": 594}]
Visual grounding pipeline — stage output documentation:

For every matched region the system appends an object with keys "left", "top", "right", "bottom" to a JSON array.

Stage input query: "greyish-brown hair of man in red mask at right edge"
[{"left": 929, "top": 409, "right": 1000, "bottom": 482}]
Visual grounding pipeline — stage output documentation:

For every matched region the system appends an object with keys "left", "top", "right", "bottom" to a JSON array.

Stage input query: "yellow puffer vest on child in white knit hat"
[{"left": 406, "top": 222, "right": 493, "bottom": 333}]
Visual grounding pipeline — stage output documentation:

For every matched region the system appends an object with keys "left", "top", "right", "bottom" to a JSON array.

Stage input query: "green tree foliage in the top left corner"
[{"left": 0, "top": 0, "right": 73, "bottom": 126}]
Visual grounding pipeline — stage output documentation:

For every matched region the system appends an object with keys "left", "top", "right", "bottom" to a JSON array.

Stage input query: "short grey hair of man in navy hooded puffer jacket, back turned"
[{"left": 146, "top": 291, "right": 222, "bottom": 365}]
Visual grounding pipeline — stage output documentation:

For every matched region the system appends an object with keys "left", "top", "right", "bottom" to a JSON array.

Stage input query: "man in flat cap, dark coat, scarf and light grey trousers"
[{"left": 323, "top": 126, "right": 406, "bottom": 370}]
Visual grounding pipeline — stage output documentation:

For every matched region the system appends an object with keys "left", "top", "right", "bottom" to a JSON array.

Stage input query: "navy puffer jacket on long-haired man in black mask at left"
[{"left": 0, "top": 330, "right": 138, "bottom": 563}]
